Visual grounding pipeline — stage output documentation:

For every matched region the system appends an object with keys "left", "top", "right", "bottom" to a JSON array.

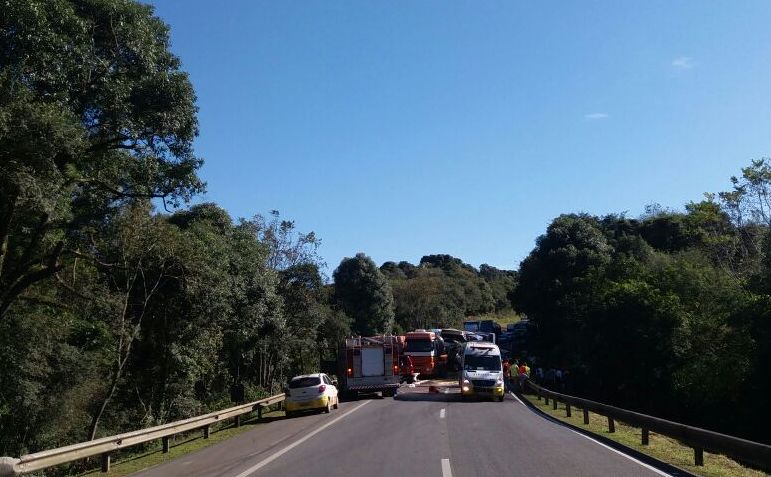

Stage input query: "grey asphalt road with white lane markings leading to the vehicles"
[{"left": 133, "top": 393, "right": 680, "bottom": 477}]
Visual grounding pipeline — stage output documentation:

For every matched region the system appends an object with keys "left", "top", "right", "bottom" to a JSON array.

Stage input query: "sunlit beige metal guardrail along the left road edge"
[{"left": 0, "top": 394, "right": 286, "bottom": 477}]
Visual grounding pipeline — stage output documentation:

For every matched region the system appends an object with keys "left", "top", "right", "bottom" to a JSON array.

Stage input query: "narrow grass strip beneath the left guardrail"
[{"left": 73, "top": 411, "right": 284, "bottom": 477}]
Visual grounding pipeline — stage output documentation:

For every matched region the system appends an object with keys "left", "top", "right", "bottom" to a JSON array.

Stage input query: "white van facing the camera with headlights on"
[{"left": 459, "top": 341, "right": 504, "bottom": 402}]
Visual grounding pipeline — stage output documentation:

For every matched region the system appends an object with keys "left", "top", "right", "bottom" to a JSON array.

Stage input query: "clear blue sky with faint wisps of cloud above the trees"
[{"left": 151, "top": 0, "right": 771, "bottom": 271}]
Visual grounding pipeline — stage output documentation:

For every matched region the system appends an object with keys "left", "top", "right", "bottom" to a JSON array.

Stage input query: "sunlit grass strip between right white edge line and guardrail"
[{"left": 524, "top": 395, "right": 768, "bottom": 477}]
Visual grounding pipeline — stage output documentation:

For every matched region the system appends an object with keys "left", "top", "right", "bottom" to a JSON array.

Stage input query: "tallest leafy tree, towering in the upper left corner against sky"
[{"left": 0, "top": 0, "right": 203, "bottom": 318}]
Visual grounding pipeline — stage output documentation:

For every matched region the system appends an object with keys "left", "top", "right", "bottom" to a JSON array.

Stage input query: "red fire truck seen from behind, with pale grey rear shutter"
[{"left": 337, "top": 335, "right": 401, "bottom": 397}]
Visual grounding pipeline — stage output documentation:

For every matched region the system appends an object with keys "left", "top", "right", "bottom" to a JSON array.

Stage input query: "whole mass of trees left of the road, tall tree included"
[{"left": 0, "top": 0, "right": 350, "bottom": 462}]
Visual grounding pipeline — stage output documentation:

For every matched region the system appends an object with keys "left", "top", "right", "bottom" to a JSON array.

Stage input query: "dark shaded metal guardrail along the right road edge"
[{"left": 527, "top": 381, "right": 771, "bottom": 470}]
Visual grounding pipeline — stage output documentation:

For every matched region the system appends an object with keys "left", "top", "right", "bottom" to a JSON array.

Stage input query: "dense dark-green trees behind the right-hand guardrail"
[{"left": 515, "top": 160, "right": 771, "bottom": 441}]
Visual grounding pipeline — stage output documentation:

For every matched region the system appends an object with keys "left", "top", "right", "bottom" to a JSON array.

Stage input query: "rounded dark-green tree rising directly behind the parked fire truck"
[{"left": 333, "top": 253, "right": 394, "bottom": 335}]
